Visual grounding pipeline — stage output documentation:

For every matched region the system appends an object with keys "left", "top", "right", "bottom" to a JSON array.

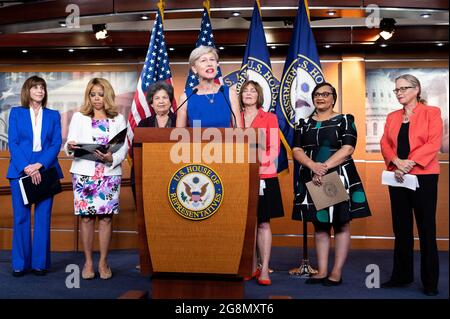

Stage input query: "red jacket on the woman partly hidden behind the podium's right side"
[{"left": 241, "top": 107, "right": 280, "bottom": 179}]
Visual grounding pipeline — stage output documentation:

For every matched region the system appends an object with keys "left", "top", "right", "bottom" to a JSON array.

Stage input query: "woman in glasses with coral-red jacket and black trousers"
[{"left": 380, "top": 74, "right": 443, "bottom": 296}]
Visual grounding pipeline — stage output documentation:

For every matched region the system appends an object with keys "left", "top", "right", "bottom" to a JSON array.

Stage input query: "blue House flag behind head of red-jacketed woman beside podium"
[{"left": 236, "top": 1, "right": 280, "bottom": 112}]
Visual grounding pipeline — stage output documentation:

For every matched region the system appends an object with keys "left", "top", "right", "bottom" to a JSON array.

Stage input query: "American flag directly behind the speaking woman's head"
[{"left": 186, "top": 1, "right": 223, "bottom": 88}]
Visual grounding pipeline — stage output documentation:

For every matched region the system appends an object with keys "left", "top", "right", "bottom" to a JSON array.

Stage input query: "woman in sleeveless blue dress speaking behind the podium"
[{"left": 176, "top": 46, "right": 242, "bottom": 127}]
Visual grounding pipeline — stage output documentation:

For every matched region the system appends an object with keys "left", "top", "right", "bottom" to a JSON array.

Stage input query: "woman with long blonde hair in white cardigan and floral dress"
[{"left": 64, "top": 78, "right": 128, "bottom": 279}]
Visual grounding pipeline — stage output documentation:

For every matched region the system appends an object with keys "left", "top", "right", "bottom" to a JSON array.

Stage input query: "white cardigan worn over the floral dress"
[{"left": 64, "top": 112, "right": 128, "bottom": 176}]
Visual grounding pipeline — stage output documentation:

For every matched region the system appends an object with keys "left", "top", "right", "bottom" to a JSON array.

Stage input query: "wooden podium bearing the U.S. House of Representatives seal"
[{"left": 133, "top": 128, "right": 259, "bottom": 299}]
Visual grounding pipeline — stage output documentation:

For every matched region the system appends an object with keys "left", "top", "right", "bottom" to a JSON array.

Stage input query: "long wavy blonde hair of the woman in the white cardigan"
[{"left": 80, "top": 78, "right": 119, "bottom": 118}]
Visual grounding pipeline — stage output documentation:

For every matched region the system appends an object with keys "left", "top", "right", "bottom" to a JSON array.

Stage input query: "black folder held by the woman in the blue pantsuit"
[{"left": 19, "top": 167, "right": 62, "bottom": 205}]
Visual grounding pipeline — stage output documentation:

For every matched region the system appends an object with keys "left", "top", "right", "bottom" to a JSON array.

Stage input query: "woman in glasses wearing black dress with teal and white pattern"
[{"left": 293, "top": 82, "right": 370, "bottom": 286}]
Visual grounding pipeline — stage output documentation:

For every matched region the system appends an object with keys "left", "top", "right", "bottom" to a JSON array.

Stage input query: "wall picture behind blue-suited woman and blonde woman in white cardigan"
[{"left": 0, "top": 71, "right": 139, "bottom": 151}]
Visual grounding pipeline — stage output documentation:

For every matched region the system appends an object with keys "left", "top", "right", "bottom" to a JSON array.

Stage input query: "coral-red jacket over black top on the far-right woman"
[{"left": 380, "top": 103, "right": 443, "bottom": 175}]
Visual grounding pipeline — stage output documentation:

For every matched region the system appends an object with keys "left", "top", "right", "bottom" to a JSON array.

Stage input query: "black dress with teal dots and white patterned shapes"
[{"left": 292, "top": 114, "right": 371, "bottom": 224}]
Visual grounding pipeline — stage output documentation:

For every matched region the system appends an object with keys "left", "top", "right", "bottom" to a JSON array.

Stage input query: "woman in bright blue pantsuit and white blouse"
[{"left": 6, "top": 76, "right": 63, "bottom": 277}]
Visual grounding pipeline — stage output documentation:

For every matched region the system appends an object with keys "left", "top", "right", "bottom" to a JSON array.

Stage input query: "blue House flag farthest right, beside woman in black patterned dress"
[{"left": 275, "top": 0, "right": 324, "bottom": 175}]
